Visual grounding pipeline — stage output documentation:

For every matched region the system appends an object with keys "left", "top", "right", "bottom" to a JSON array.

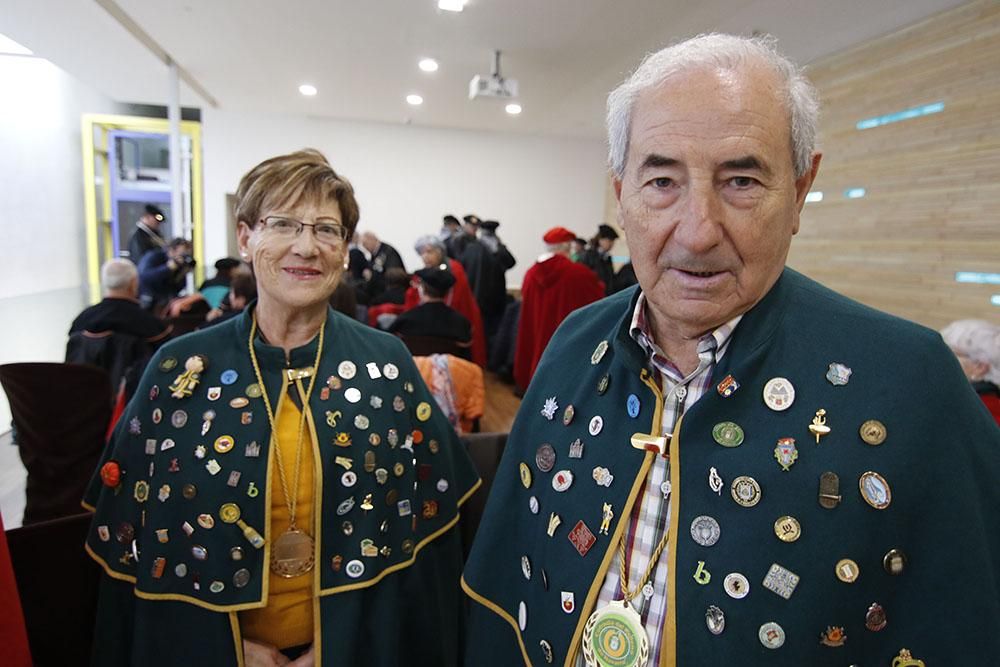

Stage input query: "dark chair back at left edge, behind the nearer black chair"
[{"left": 0, "top": 363, "right": 111, "bottom": 525}]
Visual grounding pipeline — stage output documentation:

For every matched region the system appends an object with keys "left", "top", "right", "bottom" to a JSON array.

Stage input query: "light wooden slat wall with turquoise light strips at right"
[{"left": 789, "top": 0, "right": 1000, "bottom": 328}]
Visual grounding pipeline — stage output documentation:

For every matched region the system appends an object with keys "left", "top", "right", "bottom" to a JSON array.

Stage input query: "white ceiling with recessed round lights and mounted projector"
[{"left": 0, "top": 0, "right": 962, "bottom": 137}]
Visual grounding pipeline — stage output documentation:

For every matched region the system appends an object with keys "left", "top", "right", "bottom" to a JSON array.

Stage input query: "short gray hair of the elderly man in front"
[{"left": 607, "top": 33, "right": 819, "bottom": 179}]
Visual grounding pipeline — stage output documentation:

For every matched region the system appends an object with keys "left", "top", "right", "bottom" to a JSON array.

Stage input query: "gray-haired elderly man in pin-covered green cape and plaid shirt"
[{"left": 463, "top": 35, "right": 1000, "bottom": 667}]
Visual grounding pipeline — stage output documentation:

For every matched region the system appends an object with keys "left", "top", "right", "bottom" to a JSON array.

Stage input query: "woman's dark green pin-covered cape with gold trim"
[{"left": 85, "top": 308, "right": 479, "bottom": 665}]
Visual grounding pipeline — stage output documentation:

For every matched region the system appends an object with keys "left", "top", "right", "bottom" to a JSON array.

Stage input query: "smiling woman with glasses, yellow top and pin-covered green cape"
[{"left": 86, "top": 150, "right": 479, "bottom": 666}]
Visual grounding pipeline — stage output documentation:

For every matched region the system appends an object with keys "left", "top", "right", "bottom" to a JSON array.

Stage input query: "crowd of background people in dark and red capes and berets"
[{"left": 67, "top": 204, "right": 1000, "bottom": 422}]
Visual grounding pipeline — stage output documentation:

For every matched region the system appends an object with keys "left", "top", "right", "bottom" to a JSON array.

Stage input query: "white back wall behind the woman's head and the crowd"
[{"left": 203, "top": 109, "right": 606, "bottom": 285}]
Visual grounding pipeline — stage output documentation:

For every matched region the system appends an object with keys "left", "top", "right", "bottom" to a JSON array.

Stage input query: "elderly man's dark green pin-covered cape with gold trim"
[{"left": 463, "top": 269, "right": 1000, "bottom": 667}]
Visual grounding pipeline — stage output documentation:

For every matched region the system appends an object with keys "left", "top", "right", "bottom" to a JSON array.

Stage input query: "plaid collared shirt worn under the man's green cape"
[{"left": 577, "top": 294, "right": 743, "bottom": 667}]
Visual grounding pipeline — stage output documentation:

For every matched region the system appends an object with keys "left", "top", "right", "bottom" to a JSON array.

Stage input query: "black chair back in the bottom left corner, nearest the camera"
[{"left": 3, "top": 516, "right": 100, "bottom": 667}]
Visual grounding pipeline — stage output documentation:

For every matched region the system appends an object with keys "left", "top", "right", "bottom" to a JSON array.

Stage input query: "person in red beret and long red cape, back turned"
[{"left": 514, "top": 227, "right": 604, "bottom": 389}]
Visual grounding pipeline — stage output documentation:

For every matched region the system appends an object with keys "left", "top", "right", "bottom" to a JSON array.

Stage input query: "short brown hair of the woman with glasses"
[{"left": 236, "top": 148, "right": 360, "bottom": 239}]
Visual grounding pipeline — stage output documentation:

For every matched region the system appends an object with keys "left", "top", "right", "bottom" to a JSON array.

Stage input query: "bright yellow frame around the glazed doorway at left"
[{"left": 81, "top": 114, "right": 205, "bottom": 303}]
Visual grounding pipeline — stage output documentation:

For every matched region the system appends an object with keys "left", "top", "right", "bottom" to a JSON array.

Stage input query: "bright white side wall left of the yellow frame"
[{"left": 0, "top": 55, "right": 123, "bottom": 432}]
